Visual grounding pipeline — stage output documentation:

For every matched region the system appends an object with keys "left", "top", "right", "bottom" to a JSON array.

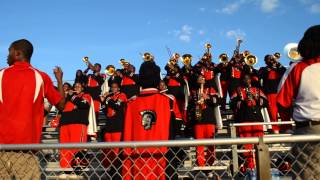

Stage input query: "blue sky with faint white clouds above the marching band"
[{"left": 0, "top": 0, "right": 320, "bottom": 80}]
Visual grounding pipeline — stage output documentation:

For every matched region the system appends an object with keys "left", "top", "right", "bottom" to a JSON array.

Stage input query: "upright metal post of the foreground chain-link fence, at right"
[{"left": 255, "top": 137, "right": 271, "bottom": 180}]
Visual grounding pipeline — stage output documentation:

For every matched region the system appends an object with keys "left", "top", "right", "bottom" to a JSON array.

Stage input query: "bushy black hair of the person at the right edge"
[{"left": 298, "top": 25, "right": 320, "bottom": 59}]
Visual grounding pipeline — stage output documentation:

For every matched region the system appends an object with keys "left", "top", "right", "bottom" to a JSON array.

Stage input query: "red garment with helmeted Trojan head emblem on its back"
[{"left": 122, "top": 88, "right": 182, "bottom": 179}]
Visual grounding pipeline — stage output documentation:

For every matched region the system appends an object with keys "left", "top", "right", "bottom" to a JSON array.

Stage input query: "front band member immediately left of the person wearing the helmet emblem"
[{"left": 101, "top": 81, "right": 127, "bottom": 178}]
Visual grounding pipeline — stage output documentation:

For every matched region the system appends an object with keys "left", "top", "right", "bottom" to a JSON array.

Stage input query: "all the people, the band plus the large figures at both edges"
[{"left": 0, "top": 25, "right": 320, "bottom": 179}]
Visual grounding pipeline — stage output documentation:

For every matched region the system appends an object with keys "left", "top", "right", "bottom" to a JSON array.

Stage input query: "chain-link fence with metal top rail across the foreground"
[{"left": 0, "top": 135, "right": 320, "bottom": 179}]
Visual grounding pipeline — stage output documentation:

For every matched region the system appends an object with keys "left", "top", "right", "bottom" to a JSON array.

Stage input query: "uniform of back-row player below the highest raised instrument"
[{"left": 227, "top": 59, "right": 245, "bottom": 96}]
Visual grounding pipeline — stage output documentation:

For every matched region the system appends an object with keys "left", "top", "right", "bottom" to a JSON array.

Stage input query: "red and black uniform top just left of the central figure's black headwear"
[{"left": 121, "top": 69, "right": 140, "bottom": 99}]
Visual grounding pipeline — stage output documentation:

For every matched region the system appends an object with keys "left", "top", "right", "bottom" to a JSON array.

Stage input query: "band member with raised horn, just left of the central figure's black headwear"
[{"left": 120, "top": 59, "right": 140, "bottom": 99}]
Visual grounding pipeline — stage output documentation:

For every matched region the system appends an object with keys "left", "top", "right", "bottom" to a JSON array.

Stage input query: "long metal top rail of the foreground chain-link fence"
[{"left": 0, "top": 134, "right": 320, "bottom": 150}]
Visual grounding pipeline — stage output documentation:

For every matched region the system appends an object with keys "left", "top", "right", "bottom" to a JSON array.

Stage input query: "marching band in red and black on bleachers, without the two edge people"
[{"left": 47, "top": 41, "right": 298, "bottom": 177}]
